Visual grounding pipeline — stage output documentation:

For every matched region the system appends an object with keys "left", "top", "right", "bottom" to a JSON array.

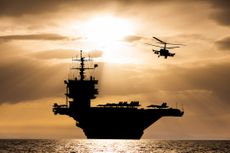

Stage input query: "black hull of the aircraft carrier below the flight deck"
[{"left": 70, "top": 108, "right": 182, "bottom": 139}]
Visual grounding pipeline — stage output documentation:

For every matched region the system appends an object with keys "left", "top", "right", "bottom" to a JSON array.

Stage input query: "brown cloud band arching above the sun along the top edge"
[{"left": 0, "top": 0, "right": 220, "bottom": 36}]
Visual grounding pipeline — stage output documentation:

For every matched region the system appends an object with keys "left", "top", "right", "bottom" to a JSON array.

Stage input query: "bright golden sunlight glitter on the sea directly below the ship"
[{"left": 56, "top": 140, "right": 171, "bottom": 153}]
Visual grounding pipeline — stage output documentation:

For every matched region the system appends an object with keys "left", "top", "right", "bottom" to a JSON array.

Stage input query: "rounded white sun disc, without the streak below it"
[{"left": 83, "top": 15, "right": 133, "bottom": 44}]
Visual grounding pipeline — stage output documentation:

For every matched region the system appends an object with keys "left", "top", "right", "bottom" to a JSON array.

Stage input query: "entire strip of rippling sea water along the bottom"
[{"left": 0, "top": 139, "right": 230, "bottom": 153}]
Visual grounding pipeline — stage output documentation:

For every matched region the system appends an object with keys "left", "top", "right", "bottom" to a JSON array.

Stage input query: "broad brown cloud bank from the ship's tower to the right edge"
[{"left": 101, "top": 63, "right": 230, "bottom": 106}]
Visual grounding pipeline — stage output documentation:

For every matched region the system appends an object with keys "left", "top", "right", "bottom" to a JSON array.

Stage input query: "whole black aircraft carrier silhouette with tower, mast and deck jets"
[{"left": 53, "top": 51, "right": 184, "bottom": 139}]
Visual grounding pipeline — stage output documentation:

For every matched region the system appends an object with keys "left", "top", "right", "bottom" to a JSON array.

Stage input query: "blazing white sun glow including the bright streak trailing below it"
[{"left": 78, "top": 15, "right": 137, "bottom": 63}]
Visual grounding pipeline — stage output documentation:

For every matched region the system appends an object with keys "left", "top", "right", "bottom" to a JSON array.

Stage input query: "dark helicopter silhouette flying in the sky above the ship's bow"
[{"left": 146, "top": 37, "right": 183, "bottom": 59}]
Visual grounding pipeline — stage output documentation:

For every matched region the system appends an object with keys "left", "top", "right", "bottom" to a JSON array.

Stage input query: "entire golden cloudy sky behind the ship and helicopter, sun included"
[{"left": 0, "top": 0, "right": 230, "bottom": 139}]
